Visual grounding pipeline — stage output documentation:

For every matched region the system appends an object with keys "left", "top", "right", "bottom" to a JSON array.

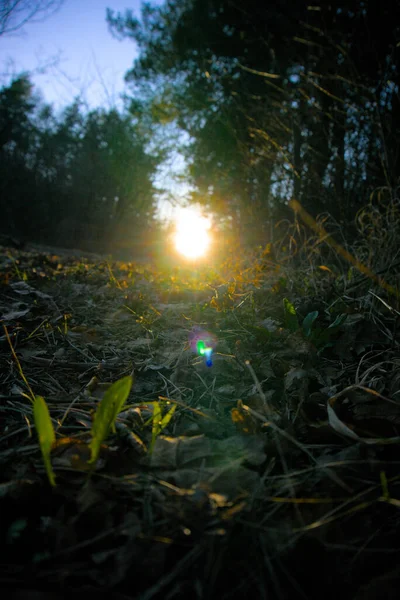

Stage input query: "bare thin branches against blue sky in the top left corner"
[{"left": 0, "top": 0, "right": 63, "bottom": 36}]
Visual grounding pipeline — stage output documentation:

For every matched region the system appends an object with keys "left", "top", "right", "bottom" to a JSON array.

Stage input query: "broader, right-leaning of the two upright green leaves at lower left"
[{"left": 88, "top": 375, "right": 133, "bottom": 464}]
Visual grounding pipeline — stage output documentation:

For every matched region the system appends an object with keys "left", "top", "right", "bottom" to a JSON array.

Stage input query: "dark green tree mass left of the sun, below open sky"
[{"left": 0, "top": 75, "right": 161, "bottom": 251}]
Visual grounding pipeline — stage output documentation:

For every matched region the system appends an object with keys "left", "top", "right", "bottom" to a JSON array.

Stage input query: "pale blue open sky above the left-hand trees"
[{"left": 0, "top": 0, "right": 146, "bottom": 108}]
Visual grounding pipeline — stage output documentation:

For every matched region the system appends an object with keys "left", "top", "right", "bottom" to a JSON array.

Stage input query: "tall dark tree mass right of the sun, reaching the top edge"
[{"left": 108, "top": 0, "right": 400, "bottom": 244}]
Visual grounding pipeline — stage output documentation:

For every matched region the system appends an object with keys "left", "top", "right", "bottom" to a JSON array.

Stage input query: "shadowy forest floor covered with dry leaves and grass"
[{"left": 0, "top": 240, "right": 400, "bottom": 600}]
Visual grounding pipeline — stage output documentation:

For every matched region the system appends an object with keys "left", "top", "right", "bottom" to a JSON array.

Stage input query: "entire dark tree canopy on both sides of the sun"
[{"left": 0, "top": 0, "right": 400, "bottom": 254}]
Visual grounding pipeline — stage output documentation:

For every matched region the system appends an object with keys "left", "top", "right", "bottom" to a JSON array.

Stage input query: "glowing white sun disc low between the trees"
[{"left": 174, "top": 208, "right": 211, "bottom": 259}]
